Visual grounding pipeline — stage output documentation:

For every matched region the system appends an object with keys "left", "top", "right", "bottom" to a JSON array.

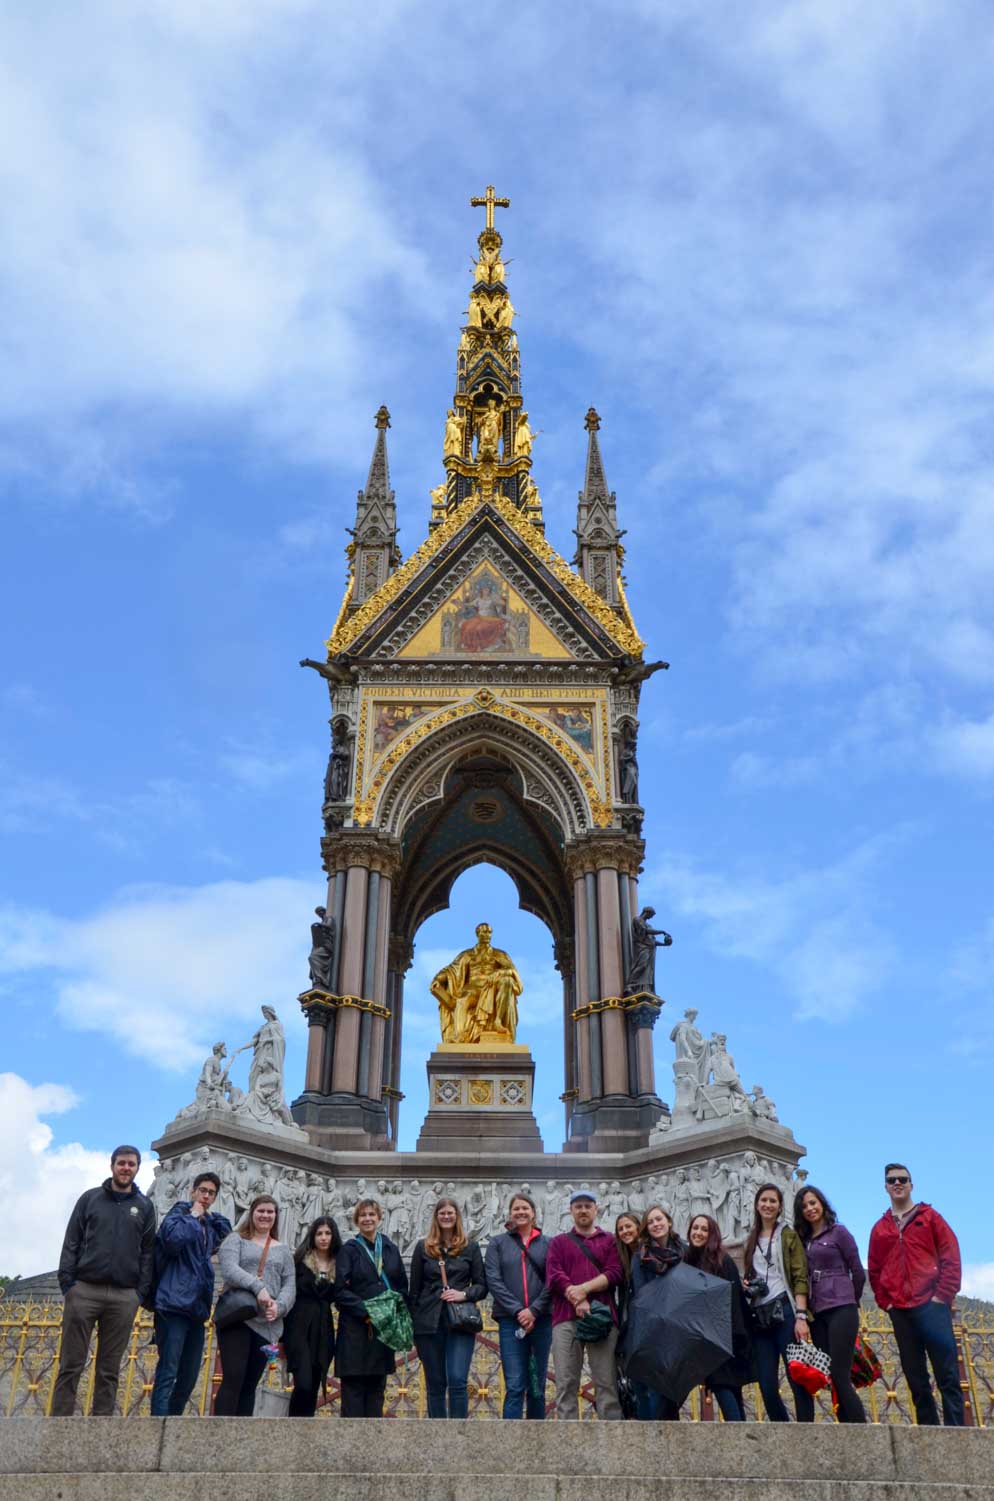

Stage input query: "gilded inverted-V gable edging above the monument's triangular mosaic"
[{"left": 326, "top": 495, "right": 644, "bottom": 657}]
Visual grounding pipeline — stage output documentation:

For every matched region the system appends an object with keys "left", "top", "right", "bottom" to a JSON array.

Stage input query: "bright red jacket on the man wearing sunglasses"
[{"left": 866, "top": 1204, "right": 962, "bottom": 1309}]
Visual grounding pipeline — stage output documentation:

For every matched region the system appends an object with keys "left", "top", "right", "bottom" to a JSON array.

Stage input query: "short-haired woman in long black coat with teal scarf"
[{"left": 333, "top": 1199, "right": 408, "bottom": 1417}]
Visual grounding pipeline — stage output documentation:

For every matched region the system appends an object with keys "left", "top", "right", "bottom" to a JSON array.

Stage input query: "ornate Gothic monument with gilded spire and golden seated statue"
[{"left": 155, "top": 186, "right": 803, "bottom": 1250}]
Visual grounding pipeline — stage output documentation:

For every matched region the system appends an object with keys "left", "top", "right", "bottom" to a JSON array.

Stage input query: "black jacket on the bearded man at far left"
[{"left": 59, "top": 1178, "right": 155, "bottom": 1301}]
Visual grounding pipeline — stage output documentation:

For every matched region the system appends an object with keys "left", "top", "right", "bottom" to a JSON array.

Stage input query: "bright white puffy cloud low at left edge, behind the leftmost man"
[{"left": 0, "top": 1073, "right": 150, "bottom": 1277}]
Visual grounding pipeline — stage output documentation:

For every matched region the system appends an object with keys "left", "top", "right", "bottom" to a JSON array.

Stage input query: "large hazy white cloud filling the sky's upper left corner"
[{"left": 0, "top": 0, "right": 432, "bottom": 504}]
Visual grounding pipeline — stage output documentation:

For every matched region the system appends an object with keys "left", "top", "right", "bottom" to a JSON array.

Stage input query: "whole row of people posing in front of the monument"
[{"left": 51, "top": 1147, "right": 964, "bottom": 1426}]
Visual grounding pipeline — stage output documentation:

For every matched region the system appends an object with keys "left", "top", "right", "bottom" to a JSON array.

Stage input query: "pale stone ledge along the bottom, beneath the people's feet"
[{"left": 0, "top": 1418, "right": 994, "bottom": 1501}]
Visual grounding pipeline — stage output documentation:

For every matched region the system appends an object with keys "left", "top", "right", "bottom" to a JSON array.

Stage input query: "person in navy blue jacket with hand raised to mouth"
[{"left": 152, "top": 1172, "right": 231, "bottom": 1417}]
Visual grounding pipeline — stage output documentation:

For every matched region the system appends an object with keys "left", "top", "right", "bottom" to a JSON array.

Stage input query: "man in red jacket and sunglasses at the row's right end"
[{"left": 866, "top": 1162, "right": 964, "bottom": 1427}]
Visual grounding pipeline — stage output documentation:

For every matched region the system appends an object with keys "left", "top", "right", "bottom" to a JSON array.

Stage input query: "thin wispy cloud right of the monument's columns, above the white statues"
[{"left": 649, "top": 835, "right": 899, "bottom": 1021}]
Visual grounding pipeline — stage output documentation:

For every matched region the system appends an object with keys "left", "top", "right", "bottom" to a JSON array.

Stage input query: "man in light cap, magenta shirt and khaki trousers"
[{"left": 545, "top": 1189, "right": 625, "bottom": 1420}]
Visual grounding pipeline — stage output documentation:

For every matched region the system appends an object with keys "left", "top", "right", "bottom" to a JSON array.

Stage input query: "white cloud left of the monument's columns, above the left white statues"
[{"left": 0, "top": 877, "right": 320, "bottom": 1070}]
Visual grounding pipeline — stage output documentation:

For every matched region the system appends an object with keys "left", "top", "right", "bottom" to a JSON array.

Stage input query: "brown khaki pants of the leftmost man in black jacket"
[{"left": 51, "top": 1282, "right": 138, "bottom": 1417}]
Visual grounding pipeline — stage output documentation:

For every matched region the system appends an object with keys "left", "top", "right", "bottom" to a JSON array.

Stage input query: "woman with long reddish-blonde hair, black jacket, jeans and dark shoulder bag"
[{"left": 411, "top": 1199, "right": 486, "bottom": 1417}]
